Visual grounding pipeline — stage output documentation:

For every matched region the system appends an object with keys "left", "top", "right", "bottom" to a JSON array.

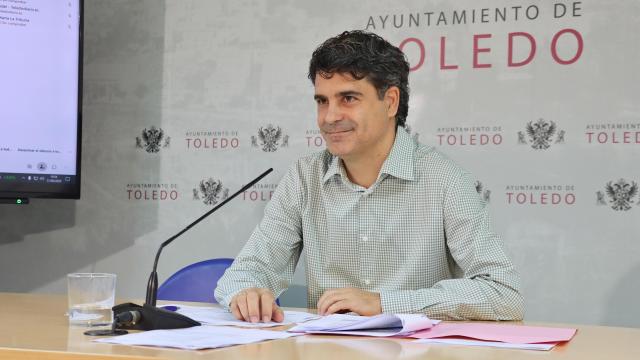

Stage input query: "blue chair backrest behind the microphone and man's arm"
[{"left": 158, "top": 258, "right": 233, "bottom": 303}]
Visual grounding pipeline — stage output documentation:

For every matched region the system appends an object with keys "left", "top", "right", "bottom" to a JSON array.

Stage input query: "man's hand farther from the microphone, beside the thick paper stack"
[{"left": 318, "top": 288, "right": 382, "bottom": 316}]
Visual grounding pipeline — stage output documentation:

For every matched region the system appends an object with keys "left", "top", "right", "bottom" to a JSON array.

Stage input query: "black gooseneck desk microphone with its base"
[{"left": 87, "top": 168, "right": 273, "bottom": 335}]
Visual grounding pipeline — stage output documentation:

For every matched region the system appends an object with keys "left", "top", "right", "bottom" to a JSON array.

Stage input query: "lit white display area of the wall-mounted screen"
[{"left": 0, "top": 0, "right": 80, "bottom": 175}]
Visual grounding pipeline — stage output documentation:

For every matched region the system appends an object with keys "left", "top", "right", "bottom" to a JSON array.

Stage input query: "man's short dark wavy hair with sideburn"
[{"left": 309, "top": 30, "right": 409, "bottom": 126}]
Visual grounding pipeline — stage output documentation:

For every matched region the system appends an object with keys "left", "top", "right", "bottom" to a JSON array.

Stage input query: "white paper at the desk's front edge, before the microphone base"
[{"left": 94, "top": 325, "right": 300, "bottom": 350}]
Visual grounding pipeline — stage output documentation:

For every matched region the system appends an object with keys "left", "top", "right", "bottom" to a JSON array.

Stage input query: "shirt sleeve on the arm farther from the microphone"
[{"left": 380, "top": 171, "right": 524, "bottom": 320}]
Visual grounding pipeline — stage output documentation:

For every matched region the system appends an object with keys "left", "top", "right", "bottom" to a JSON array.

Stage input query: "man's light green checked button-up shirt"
[{"left": 215, "top": 128, "right": 524, "bottom": 320}]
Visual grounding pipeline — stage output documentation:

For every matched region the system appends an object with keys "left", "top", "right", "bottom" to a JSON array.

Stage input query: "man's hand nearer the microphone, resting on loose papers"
[{"left": 229, "top": 288, "right": 284, "bottom": 323}]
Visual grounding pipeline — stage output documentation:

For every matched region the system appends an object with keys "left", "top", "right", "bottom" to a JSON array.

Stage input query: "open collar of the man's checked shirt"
[{"left": 322, "top": 127, "right": 415, "bottom": 183}]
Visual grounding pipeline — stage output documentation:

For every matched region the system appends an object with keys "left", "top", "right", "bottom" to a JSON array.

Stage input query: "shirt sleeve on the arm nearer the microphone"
[{"left": 215, "top": 165, "right": 303, "bottom": 308}]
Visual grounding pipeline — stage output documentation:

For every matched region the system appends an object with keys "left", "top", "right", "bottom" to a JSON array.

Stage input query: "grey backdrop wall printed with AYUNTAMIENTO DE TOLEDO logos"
[{"left": 0, "top": 0, "right": 640, "bottom": 326}]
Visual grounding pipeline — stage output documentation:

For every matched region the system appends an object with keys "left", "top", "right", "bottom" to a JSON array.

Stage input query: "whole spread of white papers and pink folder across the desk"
[{"left": 95, "top": 305, "right": 576, "bottom": 350}]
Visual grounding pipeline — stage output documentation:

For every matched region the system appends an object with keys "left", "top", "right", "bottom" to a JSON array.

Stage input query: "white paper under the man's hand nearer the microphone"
[{"left": 162, "top": 304, "right": 319, "bottom": 328}]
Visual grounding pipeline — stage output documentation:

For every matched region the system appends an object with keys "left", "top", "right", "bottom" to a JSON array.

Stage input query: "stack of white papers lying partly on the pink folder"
[{"left": 289, "top": 314, "right": 439, "bottom": 336}]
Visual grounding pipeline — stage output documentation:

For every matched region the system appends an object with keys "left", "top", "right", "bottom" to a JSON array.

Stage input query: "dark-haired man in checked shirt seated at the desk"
[{"left": 216, "top": 31, "right": 523, "bottom": 322}]
